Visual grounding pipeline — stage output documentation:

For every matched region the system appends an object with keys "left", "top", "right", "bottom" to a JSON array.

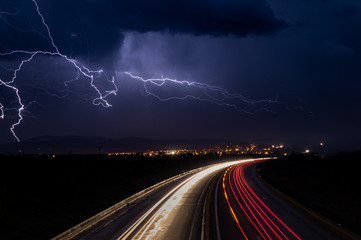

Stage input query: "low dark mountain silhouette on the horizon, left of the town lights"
[{"left": 0, "top": 136, "right": 229, "bottom": 154}]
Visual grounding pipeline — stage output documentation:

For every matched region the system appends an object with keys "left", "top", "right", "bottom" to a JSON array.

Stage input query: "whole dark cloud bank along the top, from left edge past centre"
[{"left": 0, "top": 0, "right": 285, "bottom": 66}]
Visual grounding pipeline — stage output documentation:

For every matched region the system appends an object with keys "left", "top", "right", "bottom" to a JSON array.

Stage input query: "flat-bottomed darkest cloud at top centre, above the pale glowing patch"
[{"left": 94, "top": 0, "right": 285, "bottom": 35}]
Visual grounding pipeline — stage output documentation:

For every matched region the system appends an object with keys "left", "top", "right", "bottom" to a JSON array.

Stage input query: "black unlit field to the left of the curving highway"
[{"left": 0, "top": 155, "right": 242, "bottom": 239}]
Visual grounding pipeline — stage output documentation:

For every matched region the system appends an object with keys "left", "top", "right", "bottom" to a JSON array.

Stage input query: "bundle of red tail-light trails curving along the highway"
[{"left": 225, "top": 163, "right": 301, "bottom": 240}]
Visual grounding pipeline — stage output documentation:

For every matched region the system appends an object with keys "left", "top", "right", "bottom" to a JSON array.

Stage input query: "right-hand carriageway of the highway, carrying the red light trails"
[{"left": 219, "top": 163, "right": 348, "bottom": 240}]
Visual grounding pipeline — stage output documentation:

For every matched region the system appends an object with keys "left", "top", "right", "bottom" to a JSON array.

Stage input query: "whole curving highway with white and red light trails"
[{"left": 54, "top": 159, "right": 356, "bottom": 240}]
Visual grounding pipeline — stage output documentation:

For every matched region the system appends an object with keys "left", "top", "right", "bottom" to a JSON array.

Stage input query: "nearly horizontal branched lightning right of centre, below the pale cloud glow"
[{"left": 125, "top": 72, "right": 277, "bottom": 114}]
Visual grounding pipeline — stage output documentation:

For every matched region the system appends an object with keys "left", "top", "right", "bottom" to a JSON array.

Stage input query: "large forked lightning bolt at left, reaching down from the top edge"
[{"left": 0, "top": 0, "right": 118, "bottom": 142}]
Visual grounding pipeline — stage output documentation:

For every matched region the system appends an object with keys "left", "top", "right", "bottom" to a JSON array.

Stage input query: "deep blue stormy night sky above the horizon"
[{"left": 0, "top": 0, "right": 361, "bottom": 150}]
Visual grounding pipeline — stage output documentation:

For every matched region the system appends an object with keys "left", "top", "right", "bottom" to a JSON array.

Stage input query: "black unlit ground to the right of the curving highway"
[{"left": 257, "top": 154, "right": 361, "bottom": 235}]
